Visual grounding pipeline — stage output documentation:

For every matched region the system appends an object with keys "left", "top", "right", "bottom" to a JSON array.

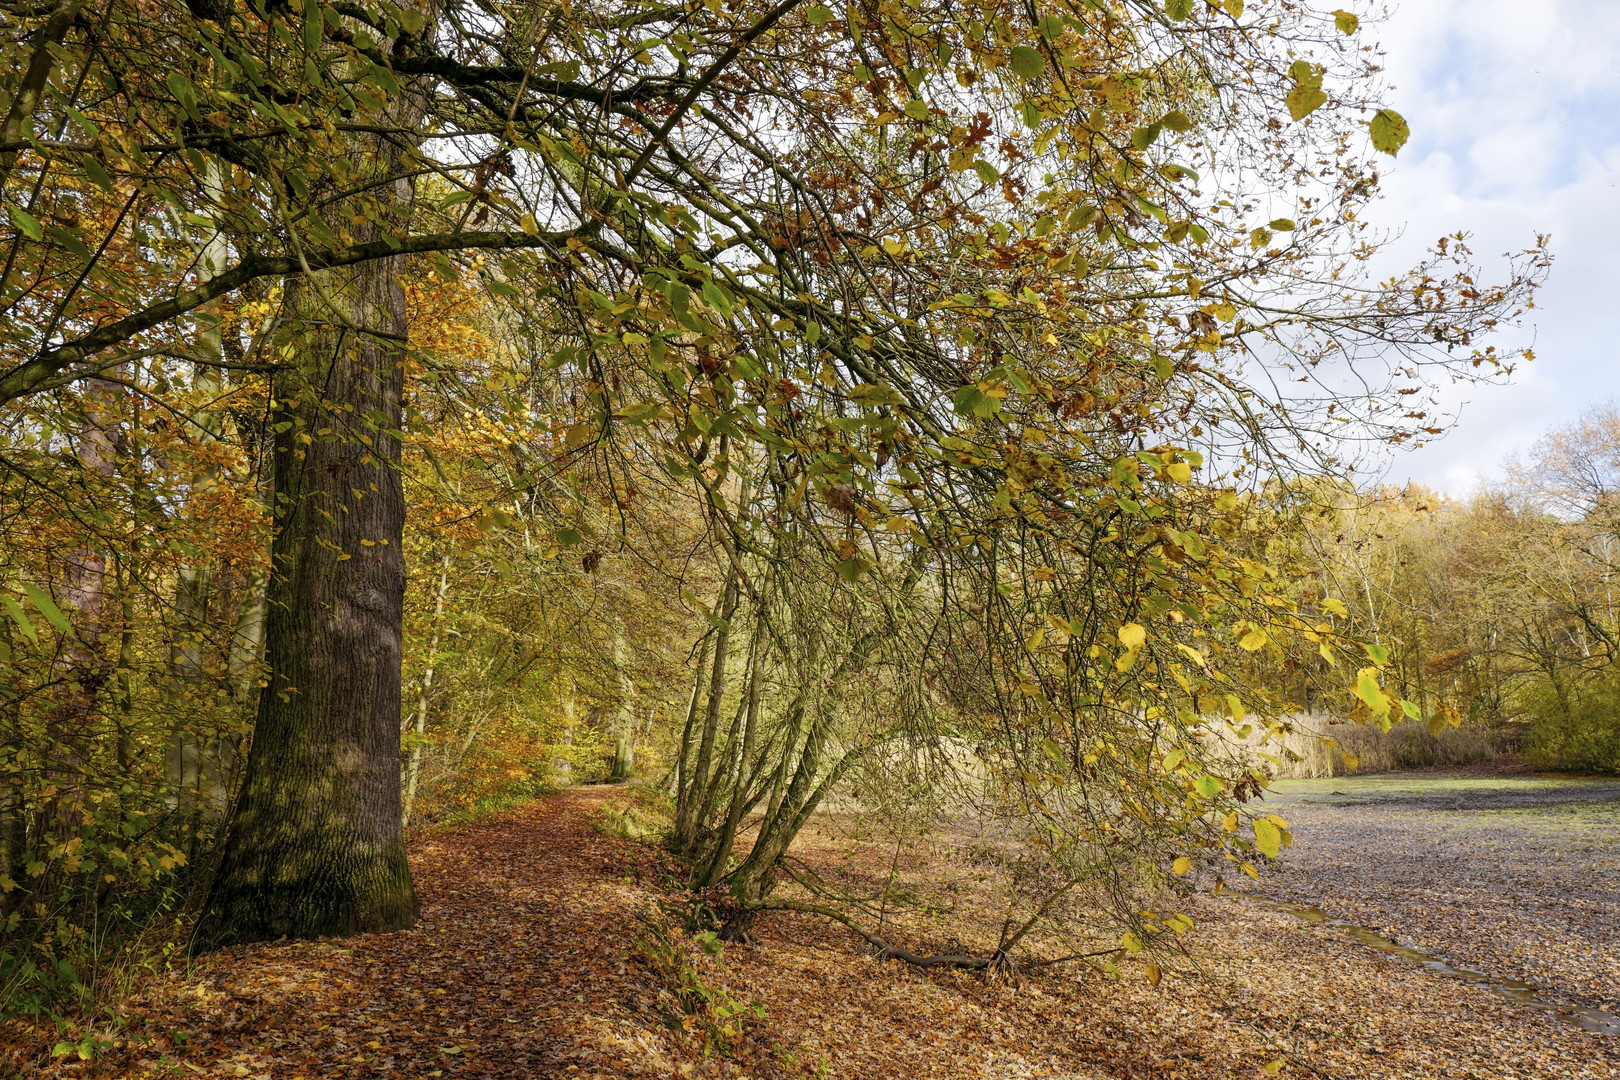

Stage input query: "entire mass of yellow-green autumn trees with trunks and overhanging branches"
[{"left": 0, "top": 0, "right": 1594, "bottom": 1049}]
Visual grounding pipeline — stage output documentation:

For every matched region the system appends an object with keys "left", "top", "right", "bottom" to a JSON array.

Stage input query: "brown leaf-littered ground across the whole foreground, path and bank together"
[{"left": 12, "top": 787, "right": 1620, "bottom": 1080}]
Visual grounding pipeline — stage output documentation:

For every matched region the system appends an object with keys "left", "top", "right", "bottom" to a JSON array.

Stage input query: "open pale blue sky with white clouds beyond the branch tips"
[{"left": 1354, "top": 0, "right": 1620, "bottom": 495}]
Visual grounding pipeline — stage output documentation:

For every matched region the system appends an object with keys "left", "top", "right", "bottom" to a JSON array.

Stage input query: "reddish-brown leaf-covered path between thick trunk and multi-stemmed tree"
[{"left": 93, "top": 787, "right": 679, "bottom": 1080}]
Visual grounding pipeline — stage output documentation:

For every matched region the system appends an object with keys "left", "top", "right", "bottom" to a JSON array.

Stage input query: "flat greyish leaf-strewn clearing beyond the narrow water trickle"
[{"left": 1262, "top": 774, "right": 1620, "bottom": 1015}]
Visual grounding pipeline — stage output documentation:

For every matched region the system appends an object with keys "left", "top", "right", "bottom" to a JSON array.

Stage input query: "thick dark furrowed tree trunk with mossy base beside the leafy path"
[{"left": 201, "top": 120, "right": 420, "bottom": 944}]
